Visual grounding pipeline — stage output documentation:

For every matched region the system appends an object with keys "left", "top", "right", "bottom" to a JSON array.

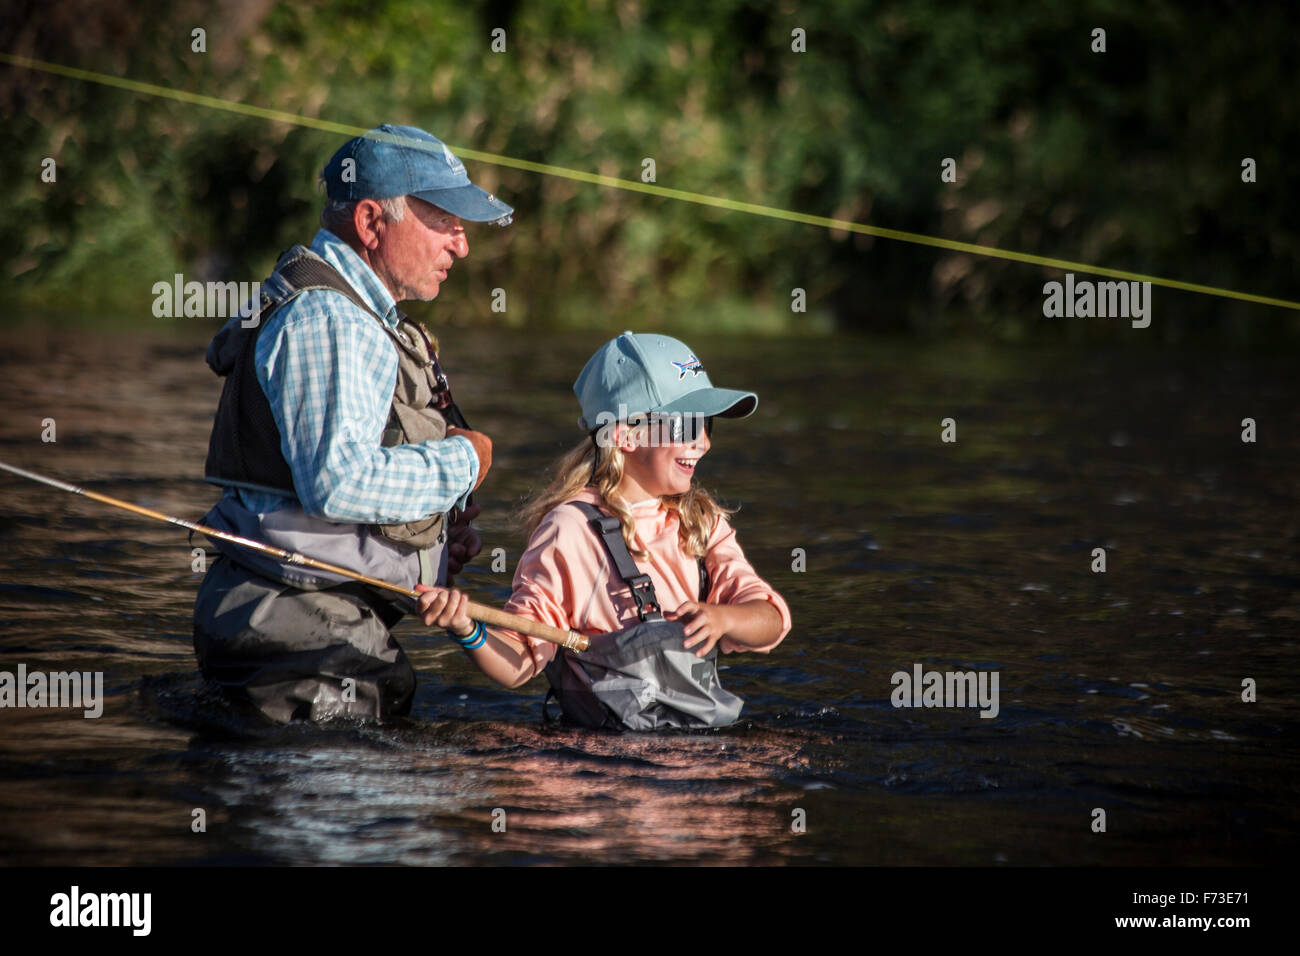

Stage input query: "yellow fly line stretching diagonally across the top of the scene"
[{"left": 0, "top": 53, "right": 1300, "bottom": 311}]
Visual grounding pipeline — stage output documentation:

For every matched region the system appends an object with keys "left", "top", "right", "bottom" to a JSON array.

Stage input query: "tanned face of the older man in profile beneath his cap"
[{"left": 371, "top": 196, "right": 469, "bottom": 302}]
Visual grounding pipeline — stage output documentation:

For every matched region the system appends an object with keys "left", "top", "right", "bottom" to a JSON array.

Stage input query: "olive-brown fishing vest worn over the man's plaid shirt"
[{"left": 204, "top": 245, "right": 450, "bottom": 550}]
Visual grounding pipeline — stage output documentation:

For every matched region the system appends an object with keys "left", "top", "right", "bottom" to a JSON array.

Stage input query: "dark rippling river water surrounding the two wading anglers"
[{"left": 0, "top": 323, "right": 1300, "bottom": 865}]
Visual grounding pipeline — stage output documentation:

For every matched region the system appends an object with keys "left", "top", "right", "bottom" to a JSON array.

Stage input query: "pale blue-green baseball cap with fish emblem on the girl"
[{"left": 573, "top": 332, "right": 758, "bottom": 431}]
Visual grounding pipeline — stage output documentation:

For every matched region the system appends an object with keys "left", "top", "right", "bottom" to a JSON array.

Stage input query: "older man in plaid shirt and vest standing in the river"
[{"left": 194, "top": 125, "right": 514, "bottom": 722}]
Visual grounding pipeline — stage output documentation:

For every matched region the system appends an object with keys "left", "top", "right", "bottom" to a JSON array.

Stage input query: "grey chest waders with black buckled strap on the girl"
[{"left": 542, "top": 501, "right": 745, "bottom": 730}]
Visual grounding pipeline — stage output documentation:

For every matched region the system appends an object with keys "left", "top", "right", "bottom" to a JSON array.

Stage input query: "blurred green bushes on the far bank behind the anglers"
[{"left": 0, "top": 0, "right": 1300, "bottom": 342}]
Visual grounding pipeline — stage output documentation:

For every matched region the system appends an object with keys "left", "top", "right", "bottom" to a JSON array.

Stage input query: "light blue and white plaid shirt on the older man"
[{"left": 228, "top": 229, "right": 478, "bottom": 524}]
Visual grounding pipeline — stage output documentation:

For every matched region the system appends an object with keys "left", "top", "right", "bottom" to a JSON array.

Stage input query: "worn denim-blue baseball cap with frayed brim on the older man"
[{"left": 321, "top": 122, "right": 515, "bottom": 225}]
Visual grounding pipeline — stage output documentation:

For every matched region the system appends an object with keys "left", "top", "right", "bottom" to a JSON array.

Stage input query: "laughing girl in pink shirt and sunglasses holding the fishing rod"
[{"left": 420, "top": 332, "right": 790, "bottom": 728}]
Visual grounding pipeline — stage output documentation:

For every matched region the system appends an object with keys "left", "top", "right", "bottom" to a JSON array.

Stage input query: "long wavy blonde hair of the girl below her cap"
[{"left": 520, "top": 438, "right": 736, "bottom": 558}]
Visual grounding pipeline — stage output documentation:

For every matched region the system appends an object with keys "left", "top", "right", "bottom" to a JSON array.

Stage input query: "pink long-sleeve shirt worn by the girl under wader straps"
[{"left": 506, "top": 488, "right": 790, "bottom": 672}]
